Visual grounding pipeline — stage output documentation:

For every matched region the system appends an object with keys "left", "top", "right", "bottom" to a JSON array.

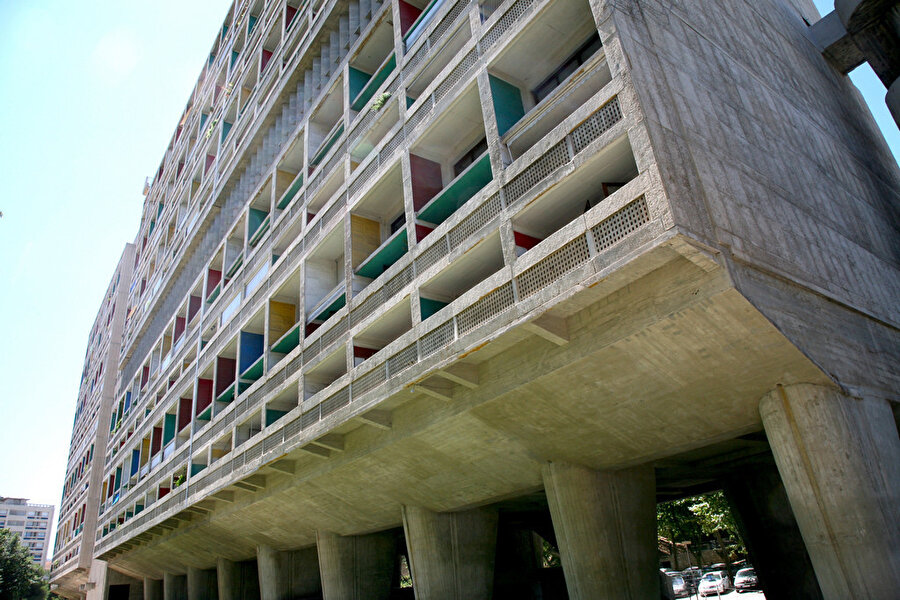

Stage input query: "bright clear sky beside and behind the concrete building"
[{"left": 0, "top": 0, "right": 900, "bottom": 552}]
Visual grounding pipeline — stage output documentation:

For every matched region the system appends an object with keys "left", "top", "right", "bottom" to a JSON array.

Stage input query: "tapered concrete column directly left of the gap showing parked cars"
[{"left": 543, "top": 462, "right": 659, "bottom": 600}]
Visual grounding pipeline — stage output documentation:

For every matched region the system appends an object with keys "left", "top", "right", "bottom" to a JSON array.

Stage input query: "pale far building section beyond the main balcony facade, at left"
[{"left": 47, "top": 244, "right": 135, "bottom": 595}]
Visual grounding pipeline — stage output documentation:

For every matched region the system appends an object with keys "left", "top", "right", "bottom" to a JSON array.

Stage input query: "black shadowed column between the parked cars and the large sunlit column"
[{"left": 724, "top": 459, "right": 822, "bottom": 600}]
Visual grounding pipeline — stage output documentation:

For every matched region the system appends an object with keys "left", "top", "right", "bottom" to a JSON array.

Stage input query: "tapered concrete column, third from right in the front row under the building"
[{"left": 403, "top": 506, "right": 497, "bottom": 600}]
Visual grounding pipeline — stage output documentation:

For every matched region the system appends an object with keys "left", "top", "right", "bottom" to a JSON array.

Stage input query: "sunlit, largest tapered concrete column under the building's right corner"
[{"left": 759, "top": 384, "right": 900, "bottom": 600}]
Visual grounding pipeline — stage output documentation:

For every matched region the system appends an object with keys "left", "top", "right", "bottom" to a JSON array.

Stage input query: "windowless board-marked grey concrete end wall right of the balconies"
[{"left": 597, "top": 0, "right": 900, "bottom": 391}]
